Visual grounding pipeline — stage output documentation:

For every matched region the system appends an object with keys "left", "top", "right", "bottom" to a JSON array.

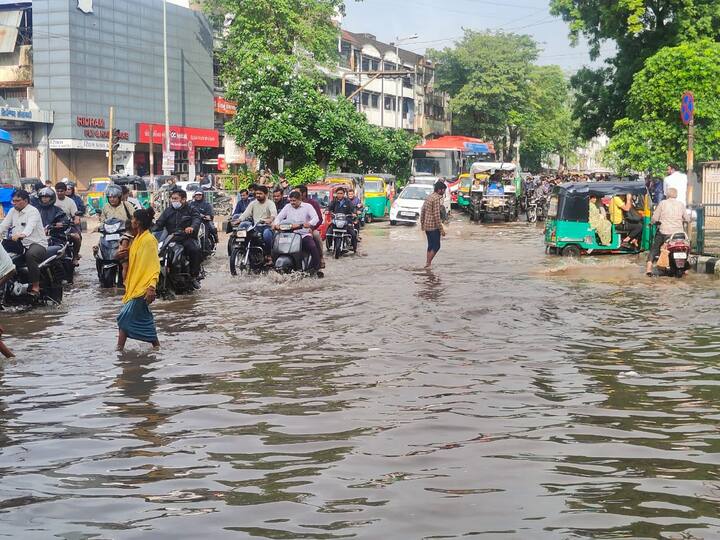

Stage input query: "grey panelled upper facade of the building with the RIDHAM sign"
[{"left": 33, "top": 0, "right": 213, "bottom": 142}]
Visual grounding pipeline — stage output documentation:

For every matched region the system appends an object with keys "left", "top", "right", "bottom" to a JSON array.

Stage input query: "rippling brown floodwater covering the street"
[{"left": 0, "top": 216, "right": 720, "bottom": 540}]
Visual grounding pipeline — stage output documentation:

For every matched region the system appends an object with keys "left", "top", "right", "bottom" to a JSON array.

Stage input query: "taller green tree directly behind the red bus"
[{"left": 429, "top": 30, "right": 538, "bottom": 158}]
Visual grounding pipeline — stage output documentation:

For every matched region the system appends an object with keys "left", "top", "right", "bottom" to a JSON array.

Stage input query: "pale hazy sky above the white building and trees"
[{"left": 343, "top": 0, "right": 612, "bottom": 72}]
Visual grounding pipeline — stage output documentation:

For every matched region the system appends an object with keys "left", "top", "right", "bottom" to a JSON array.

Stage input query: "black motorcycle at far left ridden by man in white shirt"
[{"left": 0, "top": 242, "right": 69, "bottom": 307}]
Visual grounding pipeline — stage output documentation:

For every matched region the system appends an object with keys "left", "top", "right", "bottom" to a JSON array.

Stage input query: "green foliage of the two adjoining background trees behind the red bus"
[{"left": 431, "top": 31, "right": 576, "bottom": 170}]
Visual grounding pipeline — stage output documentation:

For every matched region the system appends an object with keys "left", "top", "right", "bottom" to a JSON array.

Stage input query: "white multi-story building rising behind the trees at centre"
[{"left": 328, "top": 30, "right": 451, "bottom": 138}]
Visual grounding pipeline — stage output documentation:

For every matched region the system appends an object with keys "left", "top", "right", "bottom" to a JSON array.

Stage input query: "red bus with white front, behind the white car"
[{"left": 410, "top": 135, "right": 496, "bottom": 204}]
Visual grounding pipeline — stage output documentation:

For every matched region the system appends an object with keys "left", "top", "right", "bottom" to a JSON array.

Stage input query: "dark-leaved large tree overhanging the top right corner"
[{"left": 550, "top": 0, "right": 720, "bottom": 139}]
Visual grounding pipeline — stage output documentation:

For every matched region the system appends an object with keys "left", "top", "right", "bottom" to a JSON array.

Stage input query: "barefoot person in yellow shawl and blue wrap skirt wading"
[{"left": 117, "top": 210, "right": 160, "bottom": 351}]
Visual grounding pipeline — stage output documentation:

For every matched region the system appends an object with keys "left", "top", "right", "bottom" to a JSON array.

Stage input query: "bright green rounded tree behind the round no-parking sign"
[{"left": 609, "top": 40, "right": 720, "bottom": 175}]
